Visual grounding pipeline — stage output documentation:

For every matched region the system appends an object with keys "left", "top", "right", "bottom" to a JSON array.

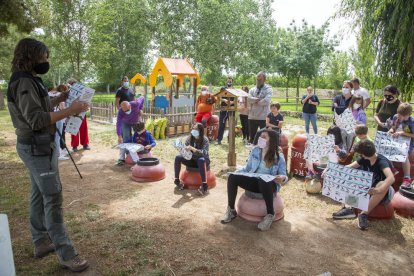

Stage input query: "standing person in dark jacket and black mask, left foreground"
[{"left": 7, "top": 38, "right": 89, "bottom": 272}]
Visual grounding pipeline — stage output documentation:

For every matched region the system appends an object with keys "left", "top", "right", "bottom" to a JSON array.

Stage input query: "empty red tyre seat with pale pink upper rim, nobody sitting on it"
[{"left": 131, "top": 157, "right": 165, "bottom": 182}]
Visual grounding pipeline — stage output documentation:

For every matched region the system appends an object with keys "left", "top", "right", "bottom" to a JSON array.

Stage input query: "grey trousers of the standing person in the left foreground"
[{"left": 16, "top": 142, "right": 77, "bottom": 261}]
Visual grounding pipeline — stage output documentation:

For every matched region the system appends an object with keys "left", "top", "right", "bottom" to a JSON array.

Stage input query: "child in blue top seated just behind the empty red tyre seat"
[{"left": 116, "top": 122, "right": 156, "bottom": 166}]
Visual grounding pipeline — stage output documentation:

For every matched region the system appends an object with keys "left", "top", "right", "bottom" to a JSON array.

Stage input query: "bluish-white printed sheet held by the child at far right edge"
[{"left": 374, "top": 131, "right": 410, "bottom": 162}]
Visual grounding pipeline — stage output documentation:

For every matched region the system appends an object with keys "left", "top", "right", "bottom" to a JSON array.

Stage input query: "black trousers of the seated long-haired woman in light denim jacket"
[{"left": 227, "top": 174, "right": 276, "bottom": 215}]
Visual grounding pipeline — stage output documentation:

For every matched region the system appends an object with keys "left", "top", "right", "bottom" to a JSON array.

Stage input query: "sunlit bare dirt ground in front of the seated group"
[{"left": 55, "top": 141, "right": 414, "bottom": 275}]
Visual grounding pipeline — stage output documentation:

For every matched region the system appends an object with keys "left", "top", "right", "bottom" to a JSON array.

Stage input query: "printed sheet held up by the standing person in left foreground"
[{"left": 65, "top": 82, "right": 95, "bottom": 135}]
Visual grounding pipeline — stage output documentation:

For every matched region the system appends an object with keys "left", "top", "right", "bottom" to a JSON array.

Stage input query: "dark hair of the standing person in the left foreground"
[{"left": 11, "top": 38, "right": 49, "bottom": 73}]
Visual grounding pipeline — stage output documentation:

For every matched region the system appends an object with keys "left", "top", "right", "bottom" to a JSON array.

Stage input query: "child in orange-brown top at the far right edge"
[{"left": 388, "top": 103, "right": 414, "bottom": 189}]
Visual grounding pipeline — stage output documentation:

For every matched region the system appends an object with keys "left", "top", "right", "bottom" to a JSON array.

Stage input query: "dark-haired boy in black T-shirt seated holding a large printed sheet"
[{"left": 332, "top": 140, "right": 395, "bottom": 230}]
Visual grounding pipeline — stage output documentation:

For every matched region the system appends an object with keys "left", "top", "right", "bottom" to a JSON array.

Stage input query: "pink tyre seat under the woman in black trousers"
[{"left": 236, "top": 191, "right": 284, "bottom": 222}]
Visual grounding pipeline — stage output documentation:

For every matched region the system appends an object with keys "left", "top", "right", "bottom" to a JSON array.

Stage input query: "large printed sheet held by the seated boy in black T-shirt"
[{"left": 322, "top": 162, "right": 373, "bottom": 211}]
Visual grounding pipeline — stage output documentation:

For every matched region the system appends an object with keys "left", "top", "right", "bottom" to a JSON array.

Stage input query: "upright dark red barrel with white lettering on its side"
[{"left": 290, "top": 134, "right": 308, "bottom": 177}]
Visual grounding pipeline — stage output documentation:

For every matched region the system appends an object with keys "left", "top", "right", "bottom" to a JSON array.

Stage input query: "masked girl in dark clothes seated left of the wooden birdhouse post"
[{"left": 174, "top": 123, "right": 210, "bottom": 195}]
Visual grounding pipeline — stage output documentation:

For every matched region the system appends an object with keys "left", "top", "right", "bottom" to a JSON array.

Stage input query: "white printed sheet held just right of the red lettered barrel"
[{"left": 303, "top": 134, "right": 335, "bottom": 167}]
